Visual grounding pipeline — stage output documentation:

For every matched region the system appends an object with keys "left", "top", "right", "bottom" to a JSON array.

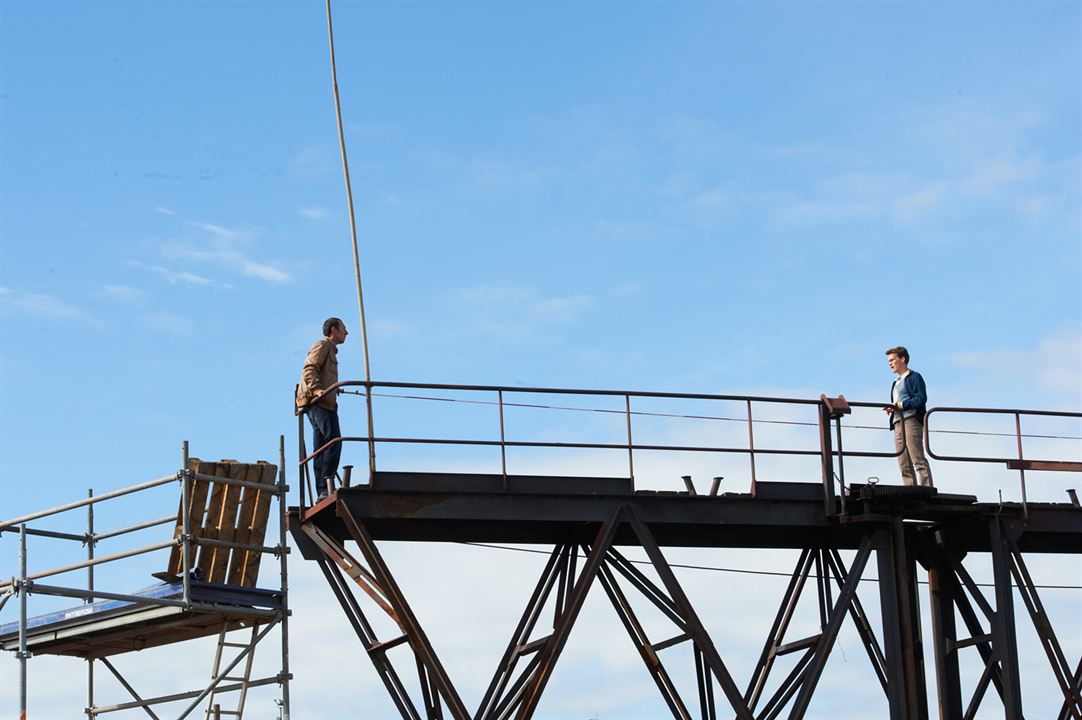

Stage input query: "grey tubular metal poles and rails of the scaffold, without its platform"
[{"left": 0, "top": 437, "right": 291, "bottom": 718}]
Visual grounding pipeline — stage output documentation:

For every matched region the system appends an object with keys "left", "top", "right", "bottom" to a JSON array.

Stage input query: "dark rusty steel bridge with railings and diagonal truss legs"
[{"left": 289, "top": 382, "right": 1082, "bottom": 720}]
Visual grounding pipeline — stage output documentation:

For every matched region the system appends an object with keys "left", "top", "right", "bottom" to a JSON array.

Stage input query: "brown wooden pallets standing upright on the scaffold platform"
[{"left": 161, "top": 458, "right": 278, "bottom": 587}]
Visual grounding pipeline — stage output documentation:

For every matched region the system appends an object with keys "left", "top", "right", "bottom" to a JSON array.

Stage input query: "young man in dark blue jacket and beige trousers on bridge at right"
[{"left": 883, "top": 345, "right": 932, "bottom": 487}]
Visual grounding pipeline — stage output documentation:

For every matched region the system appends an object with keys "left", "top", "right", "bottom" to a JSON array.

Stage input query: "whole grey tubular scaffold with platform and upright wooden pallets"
[{"left": 0, "top": 437, "right": 292, "bottom": 720}]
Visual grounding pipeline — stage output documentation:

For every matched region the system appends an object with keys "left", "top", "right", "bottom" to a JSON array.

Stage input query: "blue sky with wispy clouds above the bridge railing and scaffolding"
[{"left": 0, "top": 2, "right": 1082, "bottom": 717}]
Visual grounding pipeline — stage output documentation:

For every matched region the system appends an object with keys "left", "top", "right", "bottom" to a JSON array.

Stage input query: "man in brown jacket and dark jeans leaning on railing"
[{"left": 296, "top": 317, "right": 349, "bottom": 502}]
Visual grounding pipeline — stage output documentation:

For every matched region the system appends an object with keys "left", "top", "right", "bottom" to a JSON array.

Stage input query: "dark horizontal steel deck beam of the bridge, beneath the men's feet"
[{"left": 290, "top": 472, "right": 1082, "bottom": 559}]
